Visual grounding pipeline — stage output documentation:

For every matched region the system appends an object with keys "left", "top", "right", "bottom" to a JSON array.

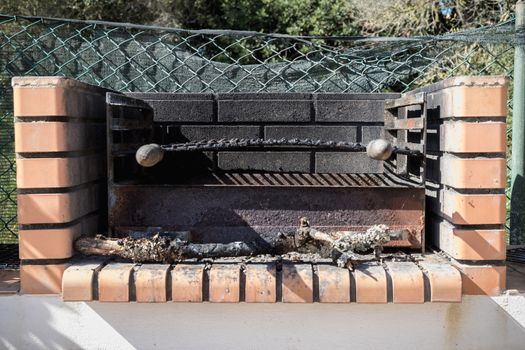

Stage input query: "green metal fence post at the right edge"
[{"left": 510, "top": 0, "right": 525, "bottom": 244}]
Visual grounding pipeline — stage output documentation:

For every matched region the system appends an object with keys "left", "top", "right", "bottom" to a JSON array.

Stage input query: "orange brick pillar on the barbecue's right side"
[{"left": 419, "top": 77, "right": 508, "bottom": 295}]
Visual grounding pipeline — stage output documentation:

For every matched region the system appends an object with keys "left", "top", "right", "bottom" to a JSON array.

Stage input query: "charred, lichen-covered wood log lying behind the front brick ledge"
[{"left": 75, "top": 224, "right": 390, "bottom": 266}]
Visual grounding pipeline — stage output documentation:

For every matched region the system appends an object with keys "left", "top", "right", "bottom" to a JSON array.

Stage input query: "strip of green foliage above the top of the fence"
[{"left": 0, "top": 0, "right": 516, "bottom": 36}]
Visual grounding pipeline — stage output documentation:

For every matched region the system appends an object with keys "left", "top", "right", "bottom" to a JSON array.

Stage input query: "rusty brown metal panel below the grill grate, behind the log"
[{"left": 109, "top": 185, "right": 425, "bottom": 248}]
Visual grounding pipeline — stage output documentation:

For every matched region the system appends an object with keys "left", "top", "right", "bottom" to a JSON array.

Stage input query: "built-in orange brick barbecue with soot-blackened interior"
[{"left": 13, "top": 77, "right": 507, "bottom": 303}]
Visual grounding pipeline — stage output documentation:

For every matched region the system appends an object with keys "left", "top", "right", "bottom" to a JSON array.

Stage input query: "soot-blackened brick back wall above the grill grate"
[{"left": 129, "top": 93, "right": 399, "bottom": 173}]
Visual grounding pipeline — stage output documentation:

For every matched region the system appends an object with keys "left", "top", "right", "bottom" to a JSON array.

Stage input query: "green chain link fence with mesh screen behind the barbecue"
[{"left": 0, "top": 15, "right": 515, "bottom": 243}]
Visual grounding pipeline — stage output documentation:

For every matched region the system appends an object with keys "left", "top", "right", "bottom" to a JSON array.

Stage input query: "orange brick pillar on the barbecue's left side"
[{"left": 12, "top": 77, "right": 106, "bottom": 294}]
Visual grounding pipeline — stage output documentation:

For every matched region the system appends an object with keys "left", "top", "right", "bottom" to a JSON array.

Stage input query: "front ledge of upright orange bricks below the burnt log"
[{"left": 62, "top": 256, "right": 462, "bottom": 304}]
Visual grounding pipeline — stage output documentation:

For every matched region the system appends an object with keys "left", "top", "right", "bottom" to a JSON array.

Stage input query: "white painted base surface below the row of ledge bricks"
[{"left": 0, "top": 296, "right": 525, "bottom": 350}]
